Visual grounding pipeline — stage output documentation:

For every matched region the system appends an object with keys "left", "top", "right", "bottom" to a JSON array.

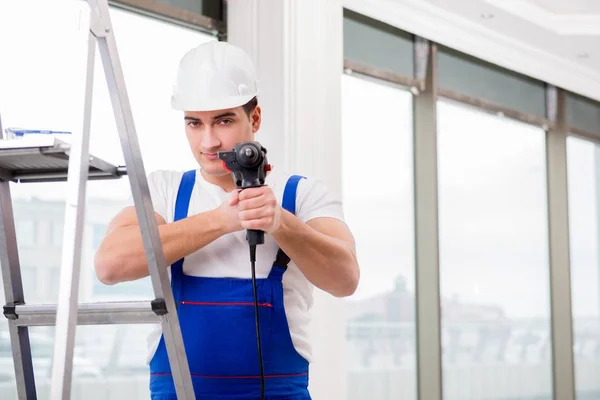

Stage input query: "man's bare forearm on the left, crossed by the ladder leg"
[{"left": 95, "top": 211, "right": 226, "bottom": 284}]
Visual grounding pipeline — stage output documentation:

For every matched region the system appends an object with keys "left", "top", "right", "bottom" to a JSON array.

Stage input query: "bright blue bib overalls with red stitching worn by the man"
[{"left": 150, "top": 170, "right": 310, "bottom": 400}]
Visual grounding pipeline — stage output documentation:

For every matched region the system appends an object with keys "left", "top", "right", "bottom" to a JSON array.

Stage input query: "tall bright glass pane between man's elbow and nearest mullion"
[{"left": 342, "top": 75, "right": 416, "bottom": 400}]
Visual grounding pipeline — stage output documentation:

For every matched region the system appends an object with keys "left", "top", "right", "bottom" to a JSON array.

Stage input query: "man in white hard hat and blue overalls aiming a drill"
[{"left": 95, "top": 41, "right": 359, "bottom": 400}]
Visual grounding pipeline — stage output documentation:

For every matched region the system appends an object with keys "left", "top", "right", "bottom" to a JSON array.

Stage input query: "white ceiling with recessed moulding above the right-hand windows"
[{"left": 343, "top": 0, "right": 600, "bottom": 101}]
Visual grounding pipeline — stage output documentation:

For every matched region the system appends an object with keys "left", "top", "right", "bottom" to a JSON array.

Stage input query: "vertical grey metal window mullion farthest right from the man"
[{"left": 546, "top": 89, "right": 575, "bottom": 400}]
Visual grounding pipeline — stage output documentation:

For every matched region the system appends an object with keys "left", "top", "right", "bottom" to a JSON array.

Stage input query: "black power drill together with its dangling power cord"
[{"left": 217, "top": 142, "right": 271, "bottom": 400}]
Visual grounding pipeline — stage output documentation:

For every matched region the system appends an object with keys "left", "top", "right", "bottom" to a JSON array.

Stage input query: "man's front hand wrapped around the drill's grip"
[{"left": 237, "top": 186, "right": 282, "bottom": 233}]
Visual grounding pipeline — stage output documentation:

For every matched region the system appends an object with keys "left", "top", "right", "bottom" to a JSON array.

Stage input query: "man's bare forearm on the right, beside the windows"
[{"left": 273, "top": 210, "right": 359, "bottom": 297}]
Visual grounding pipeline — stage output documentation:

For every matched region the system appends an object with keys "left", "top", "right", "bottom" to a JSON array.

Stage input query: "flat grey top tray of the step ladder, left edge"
[{"left": 0, "top": 136, "right": 127, "bottom": 183}]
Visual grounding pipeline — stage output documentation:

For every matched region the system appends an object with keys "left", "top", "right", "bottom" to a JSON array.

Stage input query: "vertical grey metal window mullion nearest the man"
[{"left": 413, "top": 42, "right": 442, "bottom": 400}]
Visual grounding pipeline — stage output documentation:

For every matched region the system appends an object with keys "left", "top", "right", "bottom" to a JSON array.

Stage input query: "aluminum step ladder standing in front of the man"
[{"left": 0, "top": 0, "right": 195, "bottom": 400}]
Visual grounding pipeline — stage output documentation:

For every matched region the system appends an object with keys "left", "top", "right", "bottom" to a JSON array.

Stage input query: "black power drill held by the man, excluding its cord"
[{"left": 217, "top": 142, "right": 271, "bottom": 245}]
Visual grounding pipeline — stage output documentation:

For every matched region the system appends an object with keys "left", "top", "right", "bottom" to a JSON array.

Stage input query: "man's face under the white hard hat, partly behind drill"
[{"left": 184, "top": 106, "right": 261, "bottom": 176}]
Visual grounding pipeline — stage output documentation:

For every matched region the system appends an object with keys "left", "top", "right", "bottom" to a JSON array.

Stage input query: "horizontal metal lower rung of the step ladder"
[{"left": 11, "top": 300, "right": 161, "bottom": 326}]
